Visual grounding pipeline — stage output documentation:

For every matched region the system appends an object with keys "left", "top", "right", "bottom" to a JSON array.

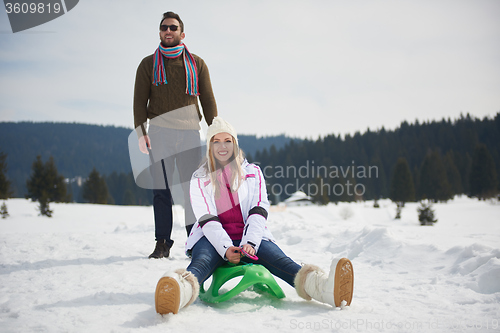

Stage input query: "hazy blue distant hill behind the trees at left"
[{"left": 0, "top": 122, "right": 291, "bottom": 199}]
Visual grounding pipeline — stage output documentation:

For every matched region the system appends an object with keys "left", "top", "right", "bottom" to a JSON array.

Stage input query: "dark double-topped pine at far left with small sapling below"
[{"left": 26, "top": 155, "right": 70, "bottom": 217}]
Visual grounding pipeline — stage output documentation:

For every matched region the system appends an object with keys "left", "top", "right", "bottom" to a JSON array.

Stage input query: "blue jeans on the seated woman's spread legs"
[{"left": 187, "top": 237, "right": 301, "bottom": 287}]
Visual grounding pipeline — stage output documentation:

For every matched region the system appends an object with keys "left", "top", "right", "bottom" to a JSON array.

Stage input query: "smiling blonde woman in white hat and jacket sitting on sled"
[{"left": 155, "top": 117, "right": 354, "bottom": 314}]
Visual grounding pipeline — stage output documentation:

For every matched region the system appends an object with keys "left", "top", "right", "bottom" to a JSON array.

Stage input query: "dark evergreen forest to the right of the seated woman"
[{"left": 249, "top": 113, "right": 500, "bottom": 204}]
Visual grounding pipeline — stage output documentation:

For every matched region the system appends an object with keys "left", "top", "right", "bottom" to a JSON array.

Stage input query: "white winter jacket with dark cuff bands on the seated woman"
[{"left": 186, "top": 160, "right": 274, "bottom": 260}]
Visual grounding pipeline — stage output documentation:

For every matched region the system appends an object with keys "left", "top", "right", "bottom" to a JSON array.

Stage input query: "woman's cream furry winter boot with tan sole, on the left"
[{"left": 155, "top": 269, "right": 200, "bottom": 314}]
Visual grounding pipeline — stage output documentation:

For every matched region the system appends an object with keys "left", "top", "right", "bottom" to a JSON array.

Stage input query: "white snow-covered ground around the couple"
[{"left": 0, "top": 197, "right": 500, "bottom": 333}]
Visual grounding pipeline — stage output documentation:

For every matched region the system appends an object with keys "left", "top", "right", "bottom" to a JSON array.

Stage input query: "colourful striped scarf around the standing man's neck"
[{"left": 153, "top": 44, "right": 200, "bottom": 96}]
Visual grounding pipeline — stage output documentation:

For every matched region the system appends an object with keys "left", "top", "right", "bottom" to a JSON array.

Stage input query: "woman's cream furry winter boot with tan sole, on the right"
[{"left": 295, "top": 258, "right": 354, "bottom": 307}]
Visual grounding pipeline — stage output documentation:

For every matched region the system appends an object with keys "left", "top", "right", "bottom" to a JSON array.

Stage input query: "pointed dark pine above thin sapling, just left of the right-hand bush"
[{"left": 390, "top": 157, "right": 415, "bottom": 219}]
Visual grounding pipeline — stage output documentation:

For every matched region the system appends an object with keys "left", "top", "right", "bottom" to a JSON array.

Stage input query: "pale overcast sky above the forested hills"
[{"left": 0, "top": 0, "right": 500, "bottom": 138}]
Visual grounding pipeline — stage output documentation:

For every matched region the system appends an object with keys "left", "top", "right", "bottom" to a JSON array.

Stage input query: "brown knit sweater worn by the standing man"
[{"left": 134, "top": 54, "right": 217, "bottom": 135}]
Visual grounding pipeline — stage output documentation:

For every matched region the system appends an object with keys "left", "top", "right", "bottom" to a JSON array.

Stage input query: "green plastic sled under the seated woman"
[{"left": 200, "top": 264, "right": 285, "bottom": 303}]
